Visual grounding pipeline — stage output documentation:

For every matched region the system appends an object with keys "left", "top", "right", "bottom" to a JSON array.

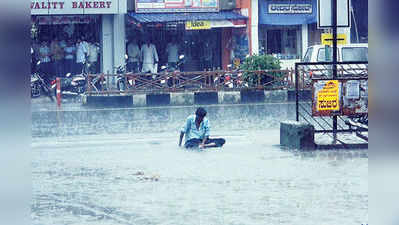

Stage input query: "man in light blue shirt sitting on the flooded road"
[{"left": 179, "top": 107, "right": 226, "bottom": 148}]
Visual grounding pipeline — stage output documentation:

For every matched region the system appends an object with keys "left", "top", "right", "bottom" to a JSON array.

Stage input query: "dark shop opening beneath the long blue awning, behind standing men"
[{"left": 126, "top": 22, "right": 222, "bottom": 72}]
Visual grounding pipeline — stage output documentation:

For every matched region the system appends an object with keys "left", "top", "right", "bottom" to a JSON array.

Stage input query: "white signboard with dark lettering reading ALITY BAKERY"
[{"left": 30, "top": 0, "right": 127, "bottom": 15}]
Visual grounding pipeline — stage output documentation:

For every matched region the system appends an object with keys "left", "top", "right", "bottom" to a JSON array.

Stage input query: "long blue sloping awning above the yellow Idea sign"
[{"left": 129, "top": 11, "right": 248, "bottom": 23}]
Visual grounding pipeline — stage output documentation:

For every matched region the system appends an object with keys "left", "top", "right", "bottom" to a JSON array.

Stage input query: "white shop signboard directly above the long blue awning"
[{"left": 136, "top": 0, "right": 219, "bottom": 13}]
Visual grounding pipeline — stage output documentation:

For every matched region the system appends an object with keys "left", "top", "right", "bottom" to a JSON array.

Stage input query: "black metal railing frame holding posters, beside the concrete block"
[{"left": 295, "top": 62, "right": 368, "bottom": 146}]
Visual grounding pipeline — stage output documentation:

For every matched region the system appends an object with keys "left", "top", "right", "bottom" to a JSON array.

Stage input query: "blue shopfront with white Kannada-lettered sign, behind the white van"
[{"left": 259, "top": 0, "right": 321, "bottom": 67}]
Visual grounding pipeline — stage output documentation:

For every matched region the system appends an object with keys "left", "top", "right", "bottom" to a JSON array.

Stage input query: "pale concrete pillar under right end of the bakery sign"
[{"left": 101, "top": 15, "right": 114, "bottom": 74}]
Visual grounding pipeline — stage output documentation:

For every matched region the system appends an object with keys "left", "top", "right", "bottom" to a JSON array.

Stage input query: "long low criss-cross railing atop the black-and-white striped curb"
[{"left": 86, "top": 70, "right": 295, "bottom": 95}]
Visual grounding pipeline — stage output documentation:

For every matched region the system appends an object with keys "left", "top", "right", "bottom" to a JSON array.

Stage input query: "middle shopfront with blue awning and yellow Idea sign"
[{"left": 126, "top": 0, "right": 249, "bottom": 71}]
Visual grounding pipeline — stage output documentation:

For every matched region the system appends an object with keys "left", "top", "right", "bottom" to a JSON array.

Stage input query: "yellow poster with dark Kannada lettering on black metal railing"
[{"left": 317, "top": 80, "right": 339, "bottom": 111}]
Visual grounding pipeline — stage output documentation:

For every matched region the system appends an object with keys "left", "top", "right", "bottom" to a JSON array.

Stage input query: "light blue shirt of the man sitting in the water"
[{"left": 181, "top": 115, "right": 210, "bottom": 141}]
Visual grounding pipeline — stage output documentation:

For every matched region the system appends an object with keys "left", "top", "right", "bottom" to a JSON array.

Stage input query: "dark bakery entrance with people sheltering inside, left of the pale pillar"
[{"left": 31, "top": 15, "right": 101, "bottom": 78}]
